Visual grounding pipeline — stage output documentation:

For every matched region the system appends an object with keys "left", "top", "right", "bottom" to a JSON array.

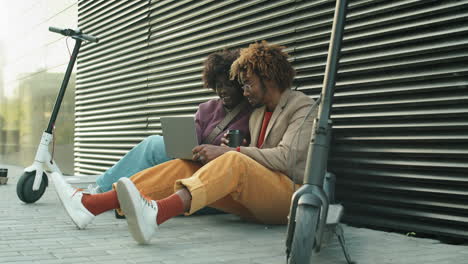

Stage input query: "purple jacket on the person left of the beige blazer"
[{"left": 195, "top": 99, "right": 252, "bottom": 145}]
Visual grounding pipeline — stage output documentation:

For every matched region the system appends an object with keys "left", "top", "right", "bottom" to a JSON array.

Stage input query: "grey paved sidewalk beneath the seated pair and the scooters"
[{"left": 0, "top": 164, "right": 468, "bottom": 264}]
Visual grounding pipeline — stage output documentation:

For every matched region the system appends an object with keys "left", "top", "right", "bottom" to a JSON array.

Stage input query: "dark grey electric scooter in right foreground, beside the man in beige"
[{"left": 286, "top": 0, "right": 354, "bottom": 264}]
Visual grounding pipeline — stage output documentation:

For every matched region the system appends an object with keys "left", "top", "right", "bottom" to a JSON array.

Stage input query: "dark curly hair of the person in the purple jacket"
[{"left": 202, "top": 49, "right": 240, "bottom": 91}]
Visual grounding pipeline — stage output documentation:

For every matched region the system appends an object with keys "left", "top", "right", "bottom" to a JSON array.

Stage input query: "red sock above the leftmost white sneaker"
[{"left": 81, "top": 190, "right": 120, "bottom": 215}]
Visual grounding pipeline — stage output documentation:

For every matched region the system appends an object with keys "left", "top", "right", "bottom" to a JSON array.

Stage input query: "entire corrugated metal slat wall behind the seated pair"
[{"left": 75, "top": 0, "right": 468, "bottom": 238}]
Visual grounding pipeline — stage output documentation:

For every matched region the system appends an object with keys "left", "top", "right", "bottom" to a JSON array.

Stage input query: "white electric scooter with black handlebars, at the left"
[{"left": 16, "top": 27, "right": 98, "bottom": 203}]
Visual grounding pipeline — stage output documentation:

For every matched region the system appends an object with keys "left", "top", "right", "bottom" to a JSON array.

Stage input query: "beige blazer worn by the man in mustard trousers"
[{"left": 240, "top": 89, "right": 317, "bottom": 184}]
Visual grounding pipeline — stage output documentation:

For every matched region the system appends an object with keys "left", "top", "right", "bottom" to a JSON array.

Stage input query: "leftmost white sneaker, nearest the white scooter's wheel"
[{"left": 51, "top": 172, "right": 94, "bottom": 229}]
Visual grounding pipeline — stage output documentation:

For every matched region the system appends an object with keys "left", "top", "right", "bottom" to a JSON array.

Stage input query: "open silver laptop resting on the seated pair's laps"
[{"left": 161, "top": 116, "right": 198, "bottom": 160}]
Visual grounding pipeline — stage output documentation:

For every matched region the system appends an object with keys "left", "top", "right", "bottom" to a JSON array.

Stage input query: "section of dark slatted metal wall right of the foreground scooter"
[{"left": 331, "top": 1, "right": 468, "bottom": 238}]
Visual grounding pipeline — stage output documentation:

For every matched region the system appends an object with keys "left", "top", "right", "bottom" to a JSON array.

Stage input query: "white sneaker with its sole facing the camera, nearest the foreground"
[{"left": 116, "top": 178, "right": 158, "bottom": 244}]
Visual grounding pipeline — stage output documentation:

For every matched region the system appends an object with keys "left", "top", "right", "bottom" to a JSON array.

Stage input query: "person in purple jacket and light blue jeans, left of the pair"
[{"left": 88, "top": 49, "right": 252, "bottom": 193}]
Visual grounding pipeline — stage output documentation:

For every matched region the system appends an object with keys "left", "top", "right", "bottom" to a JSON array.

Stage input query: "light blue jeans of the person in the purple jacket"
[{"left": 96, "top": 136, "right": 171, "bottom": 192}]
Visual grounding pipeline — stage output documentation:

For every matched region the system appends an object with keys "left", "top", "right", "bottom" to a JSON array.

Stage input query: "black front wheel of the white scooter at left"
[{"left": 16, "top": 171, "right": 49, "bottom": 203}]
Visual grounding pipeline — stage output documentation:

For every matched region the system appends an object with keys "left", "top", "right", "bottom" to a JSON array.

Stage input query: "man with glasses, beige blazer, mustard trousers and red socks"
[{"left": 53, "top": 41, "right": 313, "bottom": 244}]
